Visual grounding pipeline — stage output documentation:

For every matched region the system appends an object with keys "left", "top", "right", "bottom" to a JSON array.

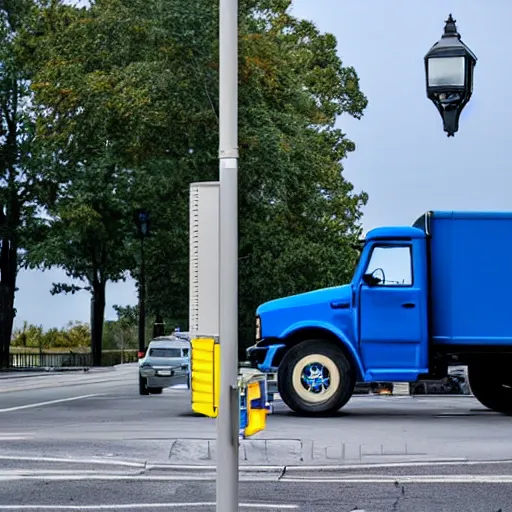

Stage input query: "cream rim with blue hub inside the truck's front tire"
[{"left": 292, "top": 354, "right": 341, "bottom": 404}]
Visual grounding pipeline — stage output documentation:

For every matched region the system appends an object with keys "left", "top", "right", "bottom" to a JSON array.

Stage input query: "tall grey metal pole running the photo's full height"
[{"left": 217, "top": 0, "right": 240, "bottom": 512}]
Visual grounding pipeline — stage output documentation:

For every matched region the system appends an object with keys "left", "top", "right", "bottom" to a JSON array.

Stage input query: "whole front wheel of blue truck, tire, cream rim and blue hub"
[{"left": 277, "top": 340, "right": 355, "bottom": 416}]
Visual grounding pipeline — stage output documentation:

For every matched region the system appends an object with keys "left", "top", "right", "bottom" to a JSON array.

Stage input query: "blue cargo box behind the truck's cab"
[{"left": 414, "top": 211, "right": 512, "bottom": 346}]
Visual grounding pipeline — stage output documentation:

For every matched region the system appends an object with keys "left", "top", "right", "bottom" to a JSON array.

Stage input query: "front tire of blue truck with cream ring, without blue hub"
[{"left": 277, "top": 340, "right": 356, "bottom": 416}]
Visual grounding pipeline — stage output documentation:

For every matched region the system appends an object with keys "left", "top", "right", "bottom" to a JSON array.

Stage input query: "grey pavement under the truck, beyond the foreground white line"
[{"left": 0, "top": 365, "right": 512, "bottom": 465}]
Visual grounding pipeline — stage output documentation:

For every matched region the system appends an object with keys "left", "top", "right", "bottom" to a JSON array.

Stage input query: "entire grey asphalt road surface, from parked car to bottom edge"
[{"left": 0, "top": 365, "right": 512, "bottom": 512}]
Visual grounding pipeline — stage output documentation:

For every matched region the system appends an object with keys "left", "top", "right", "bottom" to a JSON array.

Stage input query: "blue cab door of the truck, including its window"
[{"left": 359, "top": 239, "right": 428, "bottom": 381}]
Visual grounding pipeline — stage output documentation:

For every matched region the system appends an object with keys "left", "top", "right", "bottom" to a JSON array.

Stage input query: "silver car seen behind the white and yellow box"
[{"left": 139, "top": 336, "right": 190, "bottom": 395}]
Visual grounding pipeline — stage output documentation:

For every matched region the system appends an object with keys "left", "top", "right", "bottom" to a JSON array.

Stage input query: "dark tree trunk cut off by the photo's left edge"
[{"left": 0, "top": 234, "right": 18, "bottom": 368}]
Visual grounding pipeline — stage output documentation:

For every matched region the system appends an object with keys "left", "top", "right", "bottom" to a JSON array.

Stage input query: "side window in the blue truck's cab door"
[{"left": 366, "top": 245, "right": 413, "bottom": 286}]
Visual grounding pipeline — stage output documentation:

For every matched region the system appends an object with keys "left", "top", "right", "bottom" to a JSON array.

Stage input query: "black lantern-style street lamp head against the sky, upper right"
[{"left": 425, "top": 14, "right": 477, "bottom": 137}]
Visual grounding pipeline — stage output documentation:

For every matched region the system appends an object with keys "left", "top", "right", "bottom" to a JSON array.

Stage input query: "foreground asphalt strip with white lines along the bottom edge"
[{"left": 0, "top": 465, "right": 512, "bottom": 512}]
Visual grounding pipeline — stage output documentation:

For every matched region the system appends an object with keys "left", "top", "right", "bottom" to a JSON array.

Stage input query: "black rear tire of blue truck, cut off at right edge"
[{"left": 468, "top": 364, "right": 512, "bottom": 414}]
